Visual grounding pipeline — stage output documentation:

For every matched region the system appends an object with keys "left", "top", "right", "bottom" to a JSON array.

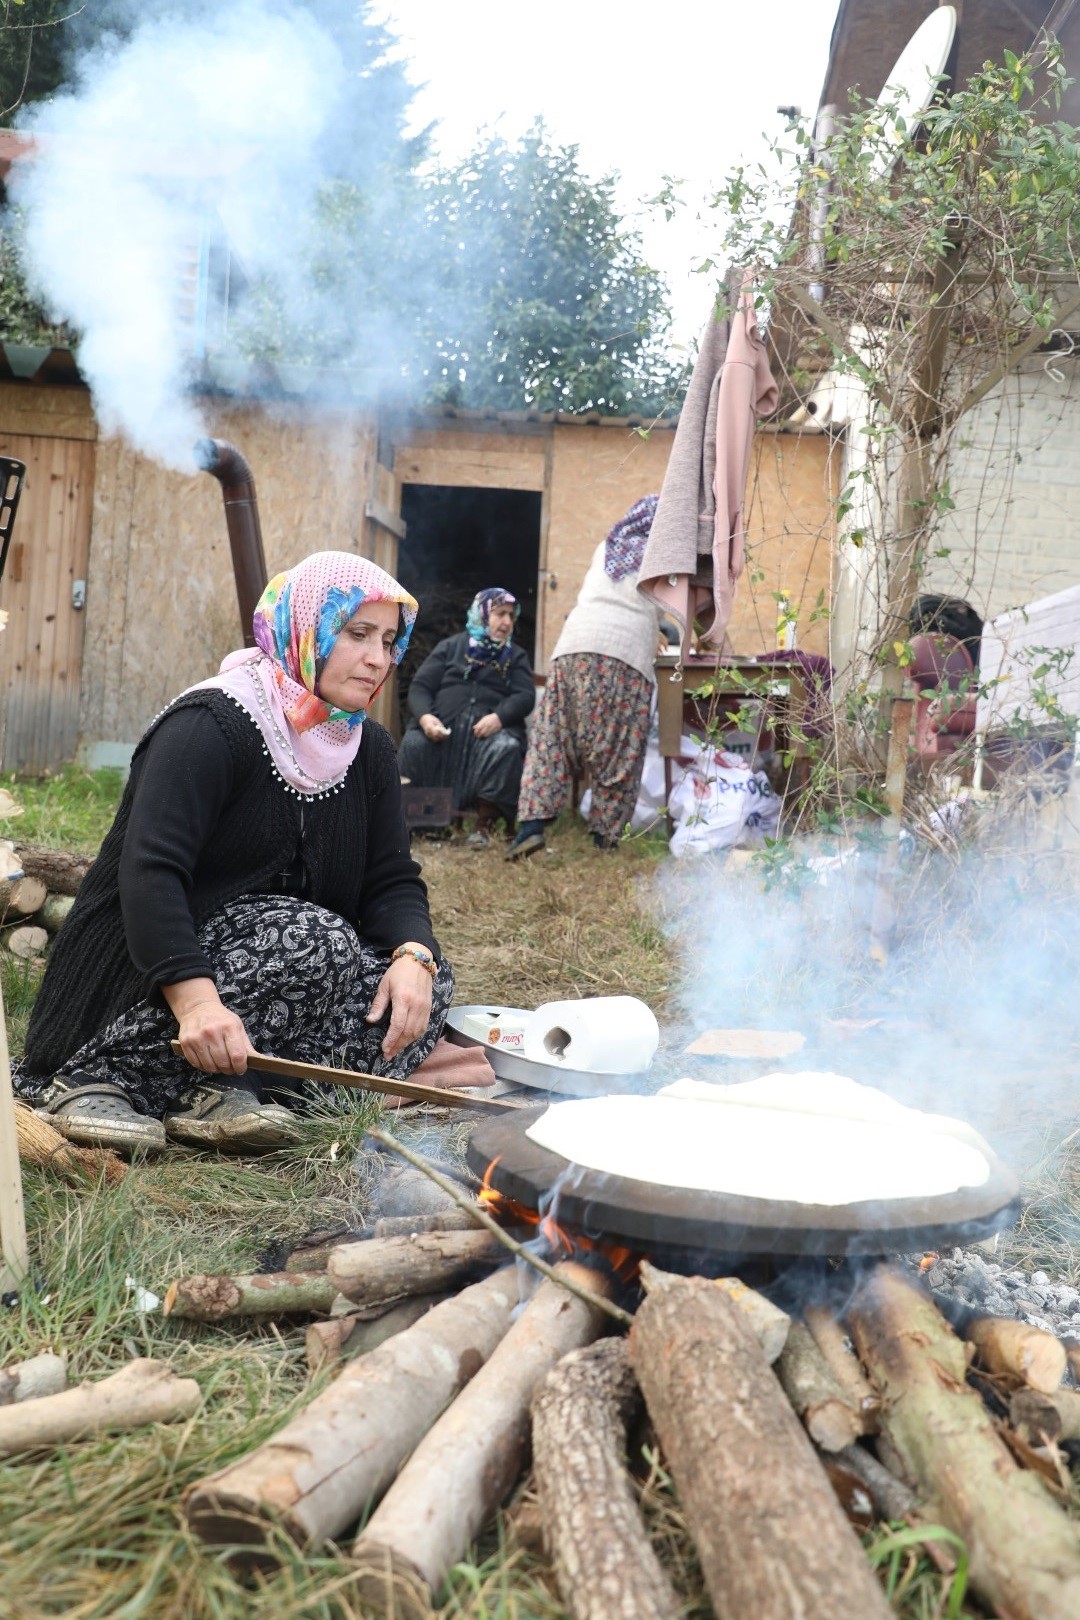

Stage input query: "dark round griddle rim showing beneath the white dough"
[{"left": 466, "top": 1108, "right": 1020, "bottom": 1257}]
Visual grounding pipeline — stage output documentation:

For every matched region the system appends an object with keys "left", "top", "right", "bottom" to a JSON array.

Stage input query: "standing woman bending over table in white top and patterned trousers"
[{"left": 507, "top": 496, "right": 661, "bottom": 860}]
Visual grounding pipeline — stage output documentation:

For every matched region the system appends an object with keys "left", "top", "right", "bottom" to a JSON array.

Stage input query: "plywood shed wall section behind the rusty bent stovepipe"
[{"left": 81, "top": 407, "right": 376, "bottom": 744}]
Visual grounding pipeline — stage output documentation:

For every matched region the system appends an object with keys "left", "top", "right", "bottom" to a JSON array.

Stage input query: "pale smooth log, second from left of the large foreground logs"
[{"left": 353, "top": 1262, "right": 604, "bottom": 1620}]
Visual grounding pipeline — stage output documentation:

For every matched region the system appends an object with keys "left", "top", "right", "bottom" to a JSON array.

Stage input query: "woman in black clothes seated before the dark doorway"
[{"left": 398, "top": 585, "right": 536, "bottom": 849}]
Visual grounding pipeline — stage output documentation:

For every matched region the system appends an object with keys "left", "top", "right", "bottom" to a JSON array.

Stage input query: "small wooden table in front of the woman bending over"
[{"left": 656, "top": 653, "right": 806, "bottom": 810}]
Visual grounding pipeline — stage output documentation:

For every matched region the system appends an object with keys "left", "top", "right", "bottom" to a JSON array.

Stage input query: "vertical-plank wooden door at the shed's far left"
[{"left": 0, "top": 433, "right": 94, "bottom": 771}]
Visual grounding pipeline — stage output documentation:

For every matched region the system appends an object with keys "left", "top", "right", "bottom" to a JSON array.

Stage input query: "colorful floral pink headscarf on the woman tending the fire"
[{"left": 191, "top": 551, "right": 416, "bottom": 795}]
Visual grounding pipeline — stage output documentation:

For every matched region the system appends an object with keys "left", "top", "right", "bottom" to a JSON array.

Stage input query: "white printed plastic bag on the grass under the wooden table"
[{"left": 669, "top": 748, "right": 780, "bottom": 855}]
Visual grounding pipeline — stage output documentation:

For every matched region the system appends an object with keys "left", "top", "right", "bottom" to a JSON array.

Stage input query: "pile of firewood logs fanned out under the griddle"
[{"left": 165, "top": 1212, "right": 1080, "bottom": 1620}]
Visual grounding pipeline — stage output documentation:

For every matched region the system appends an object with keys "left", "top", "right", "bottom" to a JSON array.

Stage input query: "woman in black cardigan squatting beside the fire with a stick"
[{"left": 18, "top": 551, "right": 453, "bottom": 1150}]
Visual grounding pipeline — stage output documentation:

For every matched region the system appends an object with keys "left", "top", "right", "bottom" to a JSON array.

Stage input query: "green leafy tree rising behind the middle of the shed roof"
[{"left": 423, "top": 126, "right": 678, "bottom": 413}]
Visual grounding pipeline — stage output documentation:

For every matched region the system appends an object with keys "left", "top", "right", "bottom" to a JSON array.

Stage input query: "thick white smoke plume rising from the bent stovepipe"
[{"left": 10, "top": 0, "right": 395, "bottom": 468}]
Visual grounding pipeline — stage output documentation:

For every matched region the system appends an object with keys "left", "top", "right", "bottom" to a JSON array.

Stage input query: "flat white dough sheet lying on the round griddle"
[{"left": 528, "top": 1074, "right": 989, "bottom": 1209}]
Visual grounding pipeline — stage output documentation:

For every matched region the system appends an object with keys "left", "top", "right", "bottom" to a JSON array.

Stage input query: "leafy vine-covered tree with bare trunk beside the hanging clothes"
[{"left": 717, "top": 41, "right": 1080, "bottom": 787}]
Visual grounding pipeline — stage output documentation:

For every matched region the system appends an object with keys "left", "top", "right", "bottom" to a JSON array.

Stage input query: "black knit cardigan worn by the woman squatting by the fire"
[{"left": 23, "top": 690, "right": 437, "bottom": 1076}]
